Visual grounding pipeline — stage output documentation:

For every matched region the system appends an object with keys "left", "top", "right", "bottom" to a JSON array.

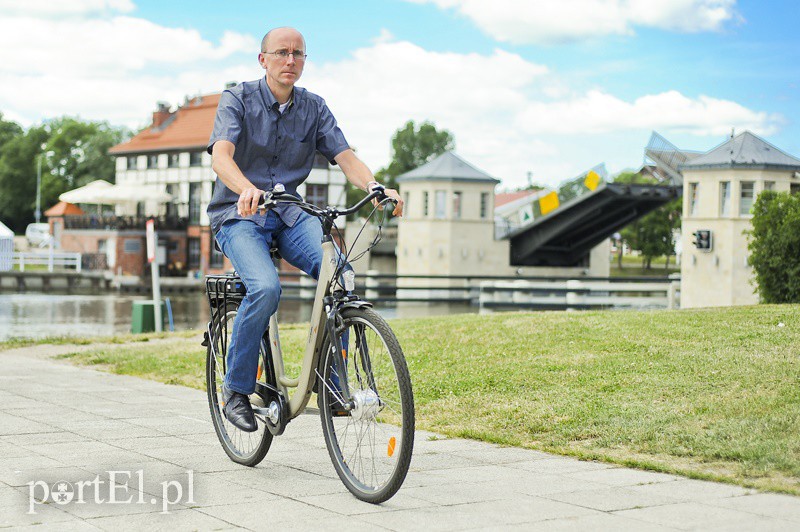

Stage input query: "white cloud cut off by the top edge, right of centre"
[{"left": 407, "top": 0, "right": 741, "bottom": 44}]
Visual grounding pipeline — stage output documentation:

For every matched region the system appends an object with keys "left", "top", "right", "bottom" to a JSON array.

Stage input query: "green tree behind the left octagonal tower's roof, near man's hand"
[{"left": 347, "top": 120, "right": 455, "bottom": 216}]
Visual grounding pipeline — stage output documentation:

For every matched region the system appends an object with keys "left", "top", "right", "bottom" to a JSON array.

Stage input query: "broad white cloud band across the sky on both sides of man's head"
[{"left": 0, "top": 9, "right": 782, "bottom": 190}]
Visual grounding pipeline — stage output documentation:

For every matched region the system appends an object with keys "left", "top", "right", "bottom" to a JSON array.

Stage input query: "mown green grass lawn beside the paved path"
[{"left": 15, "top": 305, "right": 800, "bottom": 495}]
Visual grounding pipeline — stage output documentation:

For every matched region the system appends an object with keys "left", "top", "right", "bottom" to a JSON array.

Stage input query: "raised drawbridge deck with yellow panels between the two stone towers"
[{"left": 495, "top": 132, "right": 694, "bottom": 266}]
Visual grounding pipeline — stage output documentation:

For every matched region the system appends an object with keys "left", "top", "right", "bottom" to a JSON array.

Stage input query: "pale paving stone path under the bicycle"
[{"left": 0, "top": 346, "right": 800, "bottom": 532}]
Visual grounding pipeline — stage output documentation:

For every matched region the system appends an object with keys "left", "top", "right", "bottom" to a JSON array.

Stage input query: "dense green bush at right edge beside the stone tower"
[{"left": 746, "top": 190, "right": 800, "bottom": 303}]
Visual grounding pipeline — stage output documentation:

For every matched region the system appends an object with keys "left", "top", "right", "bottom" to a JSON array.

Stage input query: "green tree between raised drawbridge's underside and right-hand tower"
[{"left": 614, "top": 172, "right": 681, "bottom": 270}]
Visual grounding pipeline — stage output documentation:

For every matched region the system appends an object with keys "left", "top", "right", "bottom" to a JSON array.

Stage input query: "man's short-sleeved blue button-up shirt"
[{"left": 208, "top": 78, "right": 349, "bottom": 232}]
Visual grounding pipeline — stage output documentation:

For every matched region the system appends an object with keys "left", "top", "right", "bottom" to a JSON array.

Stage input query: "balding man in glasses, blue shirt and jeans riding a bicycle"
[{"left": 208, "top": 28, "right": 403, "bottom": 432}]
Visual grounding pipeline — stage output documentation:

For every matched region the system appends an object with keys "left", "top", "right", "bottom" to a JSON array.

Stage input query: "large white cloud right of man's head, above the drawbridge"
[{"left": 301, "top": 41, "right": 782, "bottom": 185}]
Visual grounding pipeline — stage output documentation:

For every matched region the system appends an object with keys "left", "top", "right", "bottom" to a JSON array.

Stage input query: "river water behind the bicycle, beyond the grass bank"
[{"left": 0, "top": 292, "right": 477, "bottom": 341}]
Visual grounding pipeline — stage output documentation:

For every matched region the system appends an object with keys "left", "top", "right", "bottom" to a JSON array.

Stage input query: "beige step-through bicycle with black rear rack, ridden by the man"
[{"left": 203, "top": 185, "right": 414, "bottom": 504}]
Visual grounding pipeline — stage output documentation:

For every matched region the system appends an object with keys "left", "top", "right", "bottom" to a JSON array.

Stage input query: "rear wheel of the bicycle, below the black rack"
[{"left": 206, "top": 303, "right": 272, "bottom": 467}]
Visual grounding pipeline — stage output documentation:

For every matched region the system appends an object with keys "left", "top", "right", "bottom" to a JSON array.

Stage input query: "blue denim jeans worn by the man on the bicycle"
[{"left": 217, "top": 211, "right": 349, "bottom": 395}]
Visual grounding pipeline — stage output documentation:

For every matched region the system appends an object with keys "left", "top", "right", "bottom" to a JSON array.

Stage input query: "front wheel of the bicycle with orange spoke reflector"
[{"left": 318, "top": 308, "right": 414, "bottom": 504}]
